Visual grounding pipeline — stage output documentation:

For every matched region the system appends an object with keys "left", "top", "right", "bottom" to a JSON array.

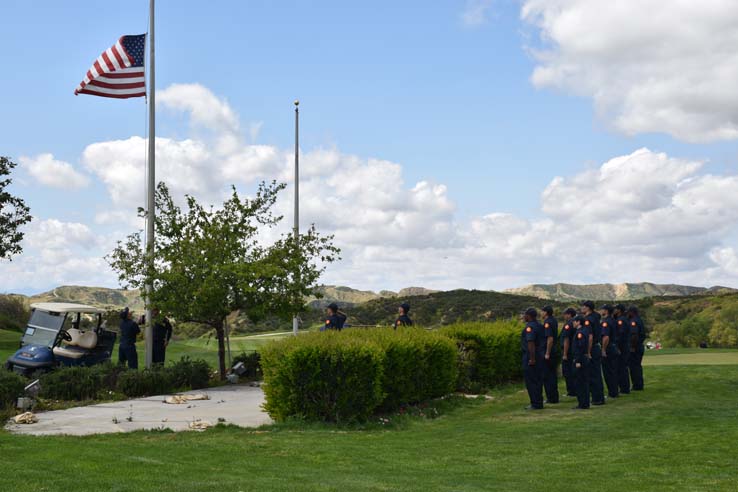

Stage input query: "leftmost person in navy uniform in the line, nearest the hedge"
[{"left": 520, "top": 308, "right": 546, "bottom": 410}]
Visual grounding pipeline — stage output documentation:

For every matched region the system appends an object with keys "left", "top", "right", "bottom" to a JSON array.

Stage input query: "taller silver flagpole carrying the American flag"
[{"left": 144, "top": 0, "right": 156, "bottom": 367}]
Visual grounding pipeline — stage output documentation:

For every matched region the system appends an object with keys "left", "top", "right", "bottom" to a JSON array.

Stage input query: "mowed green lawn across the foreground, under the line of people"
[{"left": 0, "top": 351, "right": 738, "bottom": 492}]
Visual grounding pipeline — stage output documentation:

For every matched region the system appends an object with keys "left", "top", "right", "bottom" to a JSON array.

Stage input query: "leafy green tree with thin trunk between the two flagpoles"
[{"left": 107, "top": 182, "right": 339, "bottom": 378}]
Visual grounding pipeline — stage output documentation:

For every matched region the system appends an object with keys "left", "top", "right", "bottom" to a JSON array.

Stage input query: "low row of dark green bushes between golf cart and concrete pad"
[{"left": 40, "top": 357, "right": 210, "bottom": 401}]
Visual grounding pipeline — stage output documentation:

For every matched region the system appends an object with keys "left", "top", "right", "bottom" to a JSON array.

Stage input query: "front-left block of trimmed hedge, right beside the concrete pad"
[{"left": 262, "top": 331, "right": 384, "bottom": 422}]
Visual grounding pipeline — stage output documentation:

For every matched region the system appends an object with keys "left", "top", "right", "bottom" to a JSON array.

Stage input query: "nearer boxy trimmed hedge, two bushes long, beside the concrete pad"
[{"left": 262, "top": 328, "right": 457, "bottom": 422}]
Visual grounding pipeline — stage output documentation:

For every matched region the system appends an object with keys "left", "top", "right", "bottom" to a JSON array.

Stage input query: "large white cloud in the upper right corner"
[{"left": 521, "top": 0, "right": 738, "bottom": 142}]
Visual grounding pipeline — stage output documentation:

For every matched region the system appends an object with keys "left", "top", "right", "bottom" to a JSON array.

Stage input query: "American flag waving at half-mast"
[{"left": 74, "top": 34, "right": 146, "bottom": 99}]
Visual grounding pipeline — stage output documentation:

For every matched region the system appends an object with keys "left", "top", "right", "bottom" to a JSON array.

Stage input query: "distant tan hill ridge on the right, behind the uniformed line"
[{"left": 505, "top": 282, "right": 738, "bottom": 301}]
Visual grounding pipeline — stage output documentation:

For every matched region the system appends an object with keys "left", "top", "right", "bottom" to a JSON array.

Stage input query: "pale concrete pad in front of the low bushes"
[{"left": 5, "top": 385, "right": 272, "bottom": 436}]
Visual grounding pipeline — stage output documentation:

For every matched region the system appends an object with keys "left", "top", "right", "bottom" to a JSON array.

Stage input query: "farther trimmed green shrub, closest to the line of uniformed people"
[{"left": 439, "top": 321, "right": 523, "bottom": 392}]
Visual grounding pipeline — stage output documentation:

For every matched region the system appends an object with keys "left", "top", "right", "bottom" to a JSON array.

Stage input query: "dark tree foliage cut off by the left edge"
[{"left": 0, "top": 156, "right": 31, "bottom": 260}]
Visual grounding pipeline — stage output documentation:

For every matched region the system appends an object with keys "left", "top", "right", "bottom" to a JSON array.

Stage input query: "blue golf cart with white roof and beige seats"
[{"left": 5, "top": 302, "right": 117, "bottom": 375}]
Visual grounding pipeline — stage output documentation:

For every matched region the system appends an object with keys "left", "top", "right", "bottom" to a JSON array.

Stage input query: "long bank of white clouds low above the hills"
[{"left": 0, "top": 85, "right": 738, "bottom": 291}]
